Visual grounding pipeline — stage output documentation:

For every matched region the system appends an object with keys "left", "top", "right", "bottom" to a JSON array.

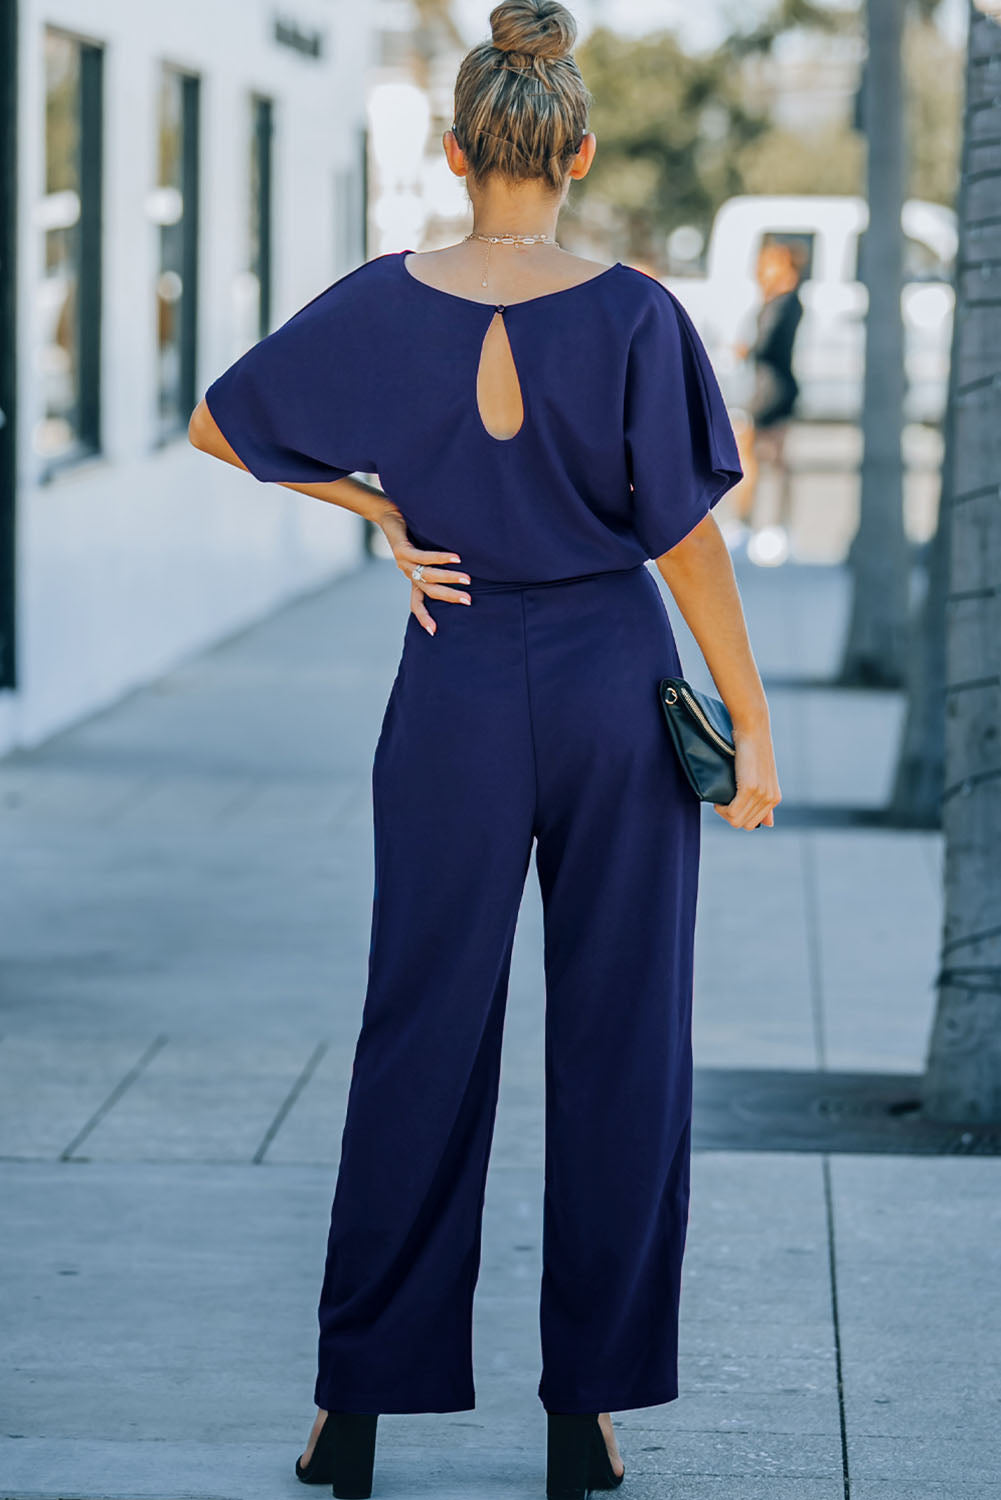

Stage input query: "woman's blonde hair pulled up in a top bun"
[{"left": 453, "top": 0, "right": 593, "bottom": 192}]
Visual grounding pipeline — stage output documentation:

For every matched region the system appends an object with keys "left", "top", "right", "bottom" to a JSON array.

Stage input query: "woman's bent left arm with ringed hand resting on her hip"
[{"left": 188, "top": 398, "right": 470, "bottom": 636}]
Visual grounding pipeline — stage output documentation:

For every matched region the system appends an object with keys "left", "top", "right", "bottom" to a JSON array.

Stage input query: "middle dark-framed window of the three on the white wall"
[{"left": 149, "top": 65, "right": 198, "bottom": 441}]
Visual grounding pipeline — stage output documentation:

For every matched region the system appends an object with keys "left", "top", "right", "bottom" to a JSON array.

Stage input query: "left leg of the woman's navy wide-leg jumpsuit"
[{"left": 315, "top": 597, "right": 534, "bottom": 1412}]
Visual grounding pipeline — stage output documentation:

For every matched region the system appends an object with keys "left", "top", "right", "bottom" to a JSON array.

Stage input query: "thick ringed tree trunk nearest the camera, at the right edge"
[{"left": 923, "top": 0, "right": 1001, "bottom": 1122}]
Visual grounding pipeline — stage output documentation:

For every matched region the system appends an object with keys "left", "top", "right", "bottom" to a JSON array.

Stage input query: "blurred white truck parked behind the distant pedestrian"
[{"left": 665, "top": 194, "right": 956, "bottom": 423}]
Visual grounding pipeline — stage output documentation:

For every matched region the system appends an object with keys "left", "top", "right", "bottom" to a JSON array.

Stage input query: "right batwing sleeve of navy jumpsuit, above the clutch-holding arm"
[{"left": 624, "top": 282, "right": 743, "bottom": 558}]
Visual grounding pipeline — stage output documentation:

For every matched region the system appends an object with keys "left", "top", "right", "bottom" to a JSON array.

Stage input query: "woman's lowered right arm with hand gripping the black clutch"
[{"left": 656, "top": 513, "right": 782, "bottom": 828}]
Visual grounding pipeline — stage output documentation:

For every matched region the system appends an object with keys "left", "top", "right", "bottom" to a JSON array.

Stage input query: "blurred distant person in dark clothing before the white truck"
[{"left": 726, "top": 240, "right": 803, "bottom": 563}]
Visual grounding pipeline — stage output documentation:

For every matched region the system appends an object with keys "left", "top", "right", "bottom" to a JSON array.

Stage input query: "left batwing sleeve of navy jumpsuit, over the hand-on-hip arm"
[{"left": 206, "top": 275, "right": 378, "bottom": 485}]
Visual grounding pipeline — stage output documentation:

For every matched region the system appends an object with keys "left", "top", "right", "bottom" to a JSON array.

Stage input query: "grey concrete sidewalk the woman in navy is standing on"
[{"left": 0, "top": 563, "right": 1001, "bottom": 1500}]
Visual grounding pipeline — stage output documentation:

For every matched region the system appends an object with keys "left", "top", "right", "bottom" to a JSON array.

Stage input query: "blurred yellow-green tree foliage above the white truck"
[{"left": 567, "top": 0, "right": 962, "bottom": 264}]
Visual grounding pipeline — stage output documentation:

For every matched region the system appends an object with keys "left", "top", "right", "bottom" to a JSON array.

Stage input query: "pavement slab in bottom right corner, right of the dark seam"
[{"left": 831, "top": 1157, "right": 1001, "bottom": 1476}]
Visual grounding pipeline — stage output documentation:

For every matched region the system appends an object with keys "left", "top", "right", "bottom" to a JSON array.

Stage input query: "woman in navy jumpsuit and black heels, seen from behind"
[{"left": 191, "top": 0, "right": 779, "bottom": 1500}]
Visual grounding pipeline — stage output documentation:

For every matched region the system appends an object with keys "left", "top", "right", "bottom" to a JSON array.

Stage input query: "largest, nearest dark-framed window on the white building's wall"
[{"left": 35, "top": 29, "right": 102, "bottom": 467}]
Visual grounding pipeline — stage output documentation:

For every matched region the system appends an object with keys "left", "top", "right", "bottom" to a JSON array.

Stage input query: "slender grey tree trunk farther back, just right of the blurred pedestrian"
[{"left": 839, "top": 0, "right": 909, "bottom": 687}]
